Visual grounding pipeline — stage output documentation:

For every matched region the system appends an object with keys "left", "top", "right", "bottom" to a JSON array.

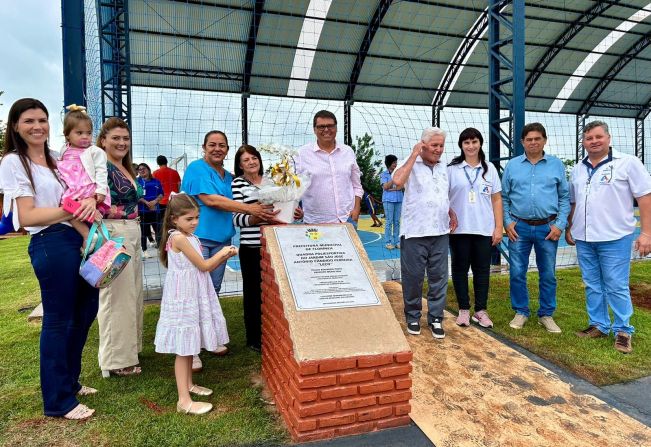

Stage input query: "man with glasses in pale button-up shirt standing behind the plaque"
[{"left": 296, "top": 110, "right": 364, "bottom": 227}]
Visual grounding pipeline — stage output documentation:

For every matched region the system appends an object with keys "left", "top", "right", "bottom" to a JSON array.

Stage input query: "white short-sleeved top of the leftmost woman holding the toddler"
[{"left": 0, "top": 153, "right": 70, "bottom": 234}]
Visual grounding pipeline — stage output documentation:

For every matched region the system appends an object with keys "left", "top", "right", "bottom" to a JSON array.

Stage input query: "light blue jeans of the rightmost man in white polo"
[{"left": 576, "top": 234, "right": 634, "bottom": 334}]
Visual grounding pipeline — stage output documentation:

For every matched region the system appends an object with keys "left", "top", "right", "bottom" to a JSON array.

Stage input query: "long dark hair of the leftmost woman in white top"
[{"left": 0, "top": 98, "right": 60, "bottom": 193}]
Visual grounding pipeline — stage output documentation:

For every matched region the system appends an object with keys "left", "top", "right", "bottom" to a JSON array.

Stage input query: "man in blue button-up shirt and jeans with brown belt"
[{"left": 502, "top": 123, "right": 570, "bottom": 333}]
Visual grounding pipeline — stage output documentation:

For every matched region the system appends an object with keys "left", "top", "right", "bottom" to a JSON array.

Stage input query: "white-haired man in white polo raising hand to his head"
[{"left": 392, "top": 127, "right": 456, "bottom": 339}]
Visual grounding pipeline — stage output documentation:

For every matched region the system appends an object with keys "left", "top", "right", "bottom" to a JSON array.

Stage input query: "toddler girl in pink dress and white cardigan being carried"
[{"left": 57, "top": 104, "right": 111, "bottom": 242}]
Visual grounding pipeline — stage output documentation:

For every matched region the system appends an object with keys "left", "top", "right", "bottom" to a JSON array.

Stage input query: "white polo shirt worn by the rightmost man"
[{"left": 570, "top": 150, "right": 651, "bottom": 242}]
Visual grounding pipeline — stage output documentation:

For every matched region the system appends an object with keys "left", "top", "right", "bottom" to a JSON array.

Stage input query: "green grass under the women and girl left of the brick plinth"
[{"left": 0, "top": 237, "right": 288, "bottom": 447}]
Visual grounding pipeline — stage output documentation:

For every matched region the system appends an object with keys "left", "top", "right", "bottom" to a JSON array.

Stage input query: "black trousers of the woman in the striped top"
[{"left": 240, "top": 245, "right": 262, "bottom": 348}]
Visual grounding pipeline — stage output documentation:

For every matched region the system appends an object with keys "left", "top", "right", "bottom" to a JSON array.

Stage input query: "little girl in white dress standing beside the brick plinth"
[{"left": 154, "top": 193, "right": 237, "bottom": 414}]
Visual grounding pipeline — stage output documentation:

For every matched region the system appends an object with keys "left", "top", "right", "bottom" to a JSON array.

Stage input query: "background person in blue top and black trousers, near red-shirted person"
[{"left": 137, "top": 163, "right": 163, "bottom": 258}]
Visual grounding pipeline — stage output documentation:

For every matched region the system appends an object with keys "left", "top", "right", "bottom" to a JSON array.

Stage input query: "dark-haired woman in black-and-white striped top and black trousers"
[{"left": 231, "top": 144, "right": 276, "bottom": 352}]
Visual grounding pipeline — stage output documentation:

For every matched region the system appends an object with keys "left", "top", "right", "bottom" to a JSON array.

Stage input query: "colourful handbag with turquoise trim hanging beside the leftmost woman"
[{"left": 79, "top": 223, "right": 131, "bottom": 289}]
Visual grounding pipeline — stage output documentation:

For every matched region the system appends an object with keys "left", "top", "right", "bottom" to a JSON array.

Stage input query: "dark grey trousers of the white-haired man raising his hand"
[{"left": 400, "top": 234, "right": 449, "bottom": 324}]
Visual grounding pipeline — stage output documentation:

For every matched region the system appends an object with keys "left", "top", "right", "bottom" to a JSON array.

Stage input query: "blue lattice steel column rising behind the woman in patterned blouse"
[{"left": 97, "top": 0, "right": 131, "bottom": 123}]
